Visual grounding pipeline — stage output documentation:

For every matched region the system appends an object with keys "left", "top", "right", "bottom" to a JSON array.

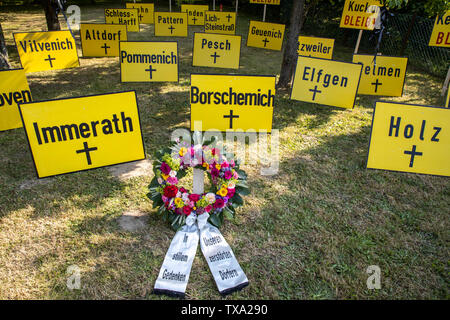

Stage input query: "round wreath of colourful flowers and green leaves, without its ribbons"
[{"left": 147, "top": 140, "right": 250, "bottom": 230}]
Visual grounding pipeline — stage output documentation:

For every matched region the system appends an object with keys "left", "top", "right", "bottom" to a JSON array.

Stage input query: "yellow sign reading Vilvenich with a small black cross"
[{"left": 14, "top": 31, "right": 80, "bottom": 73}]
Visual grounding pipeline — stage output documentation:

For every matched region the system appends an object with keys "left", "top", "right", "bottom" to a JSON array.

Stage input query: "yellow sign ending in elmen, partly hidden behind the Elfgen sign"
[{"left": 353, "top": 54, "right": 408, "bottom": 97}]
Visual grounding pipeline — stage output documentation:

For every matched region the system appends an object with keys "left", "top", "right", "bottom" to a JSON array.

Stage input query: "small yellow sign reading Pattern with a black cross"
[{"left": 155, "top": 12, "right": 188, "bottom": 37}]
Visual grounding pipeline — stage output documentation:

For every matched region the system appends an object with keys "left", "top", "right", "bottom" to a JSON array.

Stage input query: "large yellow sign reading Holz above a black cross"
[{"left": 367, "top": 102, "right": 450, "bottom": 176}]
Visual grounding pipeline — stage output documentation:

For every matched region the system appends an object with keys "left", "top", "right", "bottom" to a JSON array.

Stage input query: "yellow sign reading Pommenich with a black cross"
[{"left": 120, "top": 41, "right": 178, "bottom": 82}]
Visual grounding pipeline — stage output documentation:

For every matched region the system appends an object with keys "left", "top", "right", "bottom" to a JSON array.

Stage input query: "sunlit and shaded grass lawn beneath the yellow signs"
[{"left": 0, "top": 6, "right": 450, "bottom": 299}]
